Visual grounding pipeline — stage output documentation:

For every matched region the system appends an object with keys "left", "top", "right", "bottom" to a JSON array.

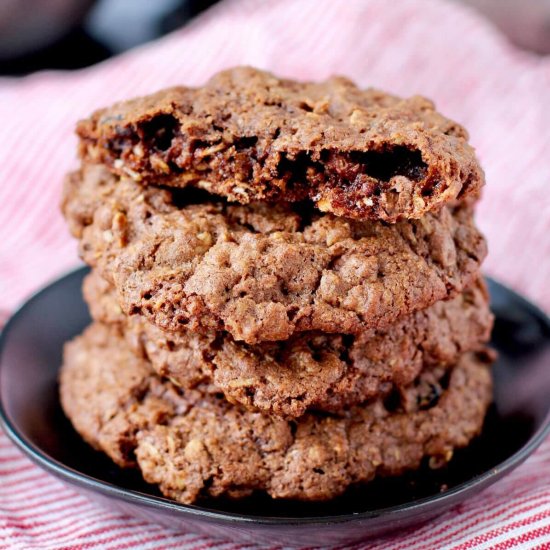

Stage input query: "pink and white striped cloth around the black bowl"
[{"left": 0, "top": 0, "right": 550, "bottom": 549}]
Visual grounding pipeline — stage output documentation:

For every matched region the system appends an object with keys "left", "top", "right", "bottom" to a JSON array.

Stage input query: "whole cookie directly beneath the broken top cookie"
[{"left": 63, "top": 165, "right": 486, "bottom": 344}]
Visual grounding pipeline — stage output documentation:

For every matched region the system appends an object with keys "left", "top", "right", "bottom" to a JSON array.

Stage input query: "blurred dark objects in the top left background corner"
[{"left": 0, "top": 0, "right": 218, "bottom": 75}]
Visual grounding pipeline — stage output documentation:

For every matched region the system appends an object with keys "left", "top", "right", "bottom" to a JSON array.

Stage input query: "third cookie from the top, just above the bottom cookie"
[{"left": 83, "top": 272, "right": 493, "bottom": 417}]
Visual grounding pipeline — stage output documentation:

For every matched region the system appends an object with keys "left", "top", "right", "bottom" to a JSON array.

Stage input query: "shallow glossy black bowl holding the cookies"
[{"left": 0, "top": 269, "right": 550, "bottom": 545}]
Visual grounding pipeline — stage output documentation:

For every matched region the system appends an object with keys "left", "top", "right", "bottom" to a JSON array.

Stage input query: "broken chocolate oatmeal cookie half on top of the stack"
[{"left": 77, "top": 67, "right": 484, "bottom": 222}]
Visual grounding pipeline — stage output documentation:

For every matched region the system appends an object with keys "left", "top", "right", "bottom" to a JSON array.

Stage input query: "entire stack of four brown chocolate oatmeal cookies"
[{"left": 61, "top": 68, "right": 492, "bottom": 503}]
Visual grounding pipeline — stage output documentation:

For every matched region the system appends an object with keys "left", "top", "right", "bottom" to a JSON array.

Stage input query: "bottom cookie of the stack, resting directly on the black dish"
[{"left": 61, "top": 325, "right": 491, "bottom": 503}]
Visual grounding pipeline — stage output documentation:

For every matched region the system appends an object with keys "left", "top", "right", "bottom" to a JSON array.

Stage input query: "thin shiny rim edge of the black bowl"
[{"left": 0, "top": 266, "right": 550, "bottom": 526}]
